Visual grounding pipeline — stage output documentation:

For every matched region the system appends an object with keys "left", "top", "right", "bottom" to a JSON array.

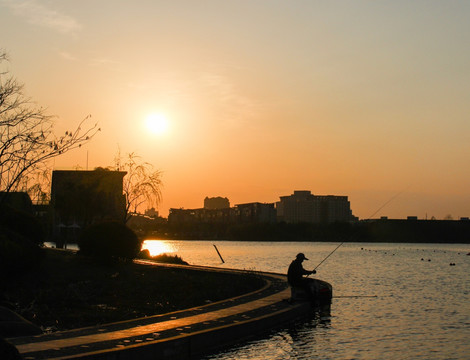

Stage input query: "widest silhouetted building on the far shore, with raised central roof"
[{"left": 276, "top": 190, "right": 354, "bottom": 224}]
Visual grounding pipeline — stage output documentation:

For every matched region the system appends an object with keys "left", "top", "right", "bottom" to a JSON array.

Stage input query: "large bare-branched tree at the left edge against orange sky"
[{"left": 0, "top": 50, "right": 100, "bottom": 203}]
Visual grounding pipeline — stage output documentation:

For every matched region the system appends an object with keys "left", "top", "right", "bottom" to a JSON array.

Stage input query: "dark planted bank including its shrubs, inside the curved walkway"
[{"left": 0, "top": 208, "right": 263, "bottom": 334}]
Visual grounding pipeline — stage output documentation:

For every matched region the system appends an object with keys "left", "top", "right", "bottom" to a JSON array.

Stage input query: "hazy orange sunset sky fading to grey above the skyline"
[{"left": 0, "top": 0, "right": 470, "bottom": 218}]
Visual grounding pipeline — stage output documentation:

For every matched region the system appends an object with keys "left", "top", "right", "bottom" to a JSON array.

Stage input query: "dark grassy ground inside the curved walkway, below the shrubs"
[{"left": 2, "top": 249, "right": 263, "bottom": 330}]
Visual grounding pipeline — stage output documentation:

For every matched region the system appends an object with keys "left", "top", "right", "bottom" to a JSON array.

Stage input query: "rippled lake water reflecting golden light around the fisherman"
[{"left": 147, "top": 241, "right": 470, "bottom": 360}]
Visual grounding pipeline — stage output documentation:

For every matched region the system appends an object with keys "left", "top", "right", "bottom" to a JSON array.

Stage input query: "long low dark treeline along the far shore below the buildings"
[{"left": 147, "top": 220, "right": 470, "bottom": 244}]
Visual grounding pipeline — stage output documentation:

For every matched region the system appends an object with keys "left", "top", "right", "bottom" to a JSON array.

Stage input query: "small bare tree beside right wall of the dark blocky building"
[{"left": 114, "top": 151, "right": 163, "bottom": 222}]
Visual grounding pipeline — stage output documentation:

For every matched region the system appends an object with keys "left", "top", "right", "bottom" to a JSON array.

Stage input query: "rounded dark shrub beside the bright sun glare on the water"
[{"left": 78, "top": 221, "right": 142, "bottom": 260}]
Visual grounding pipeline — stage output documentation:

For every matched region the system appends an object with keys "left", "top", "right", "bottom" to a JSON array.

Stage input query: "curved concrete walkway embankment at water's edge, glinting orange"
[{"left": 8, "top": 267, "right": 312, "bottom": 359}]
